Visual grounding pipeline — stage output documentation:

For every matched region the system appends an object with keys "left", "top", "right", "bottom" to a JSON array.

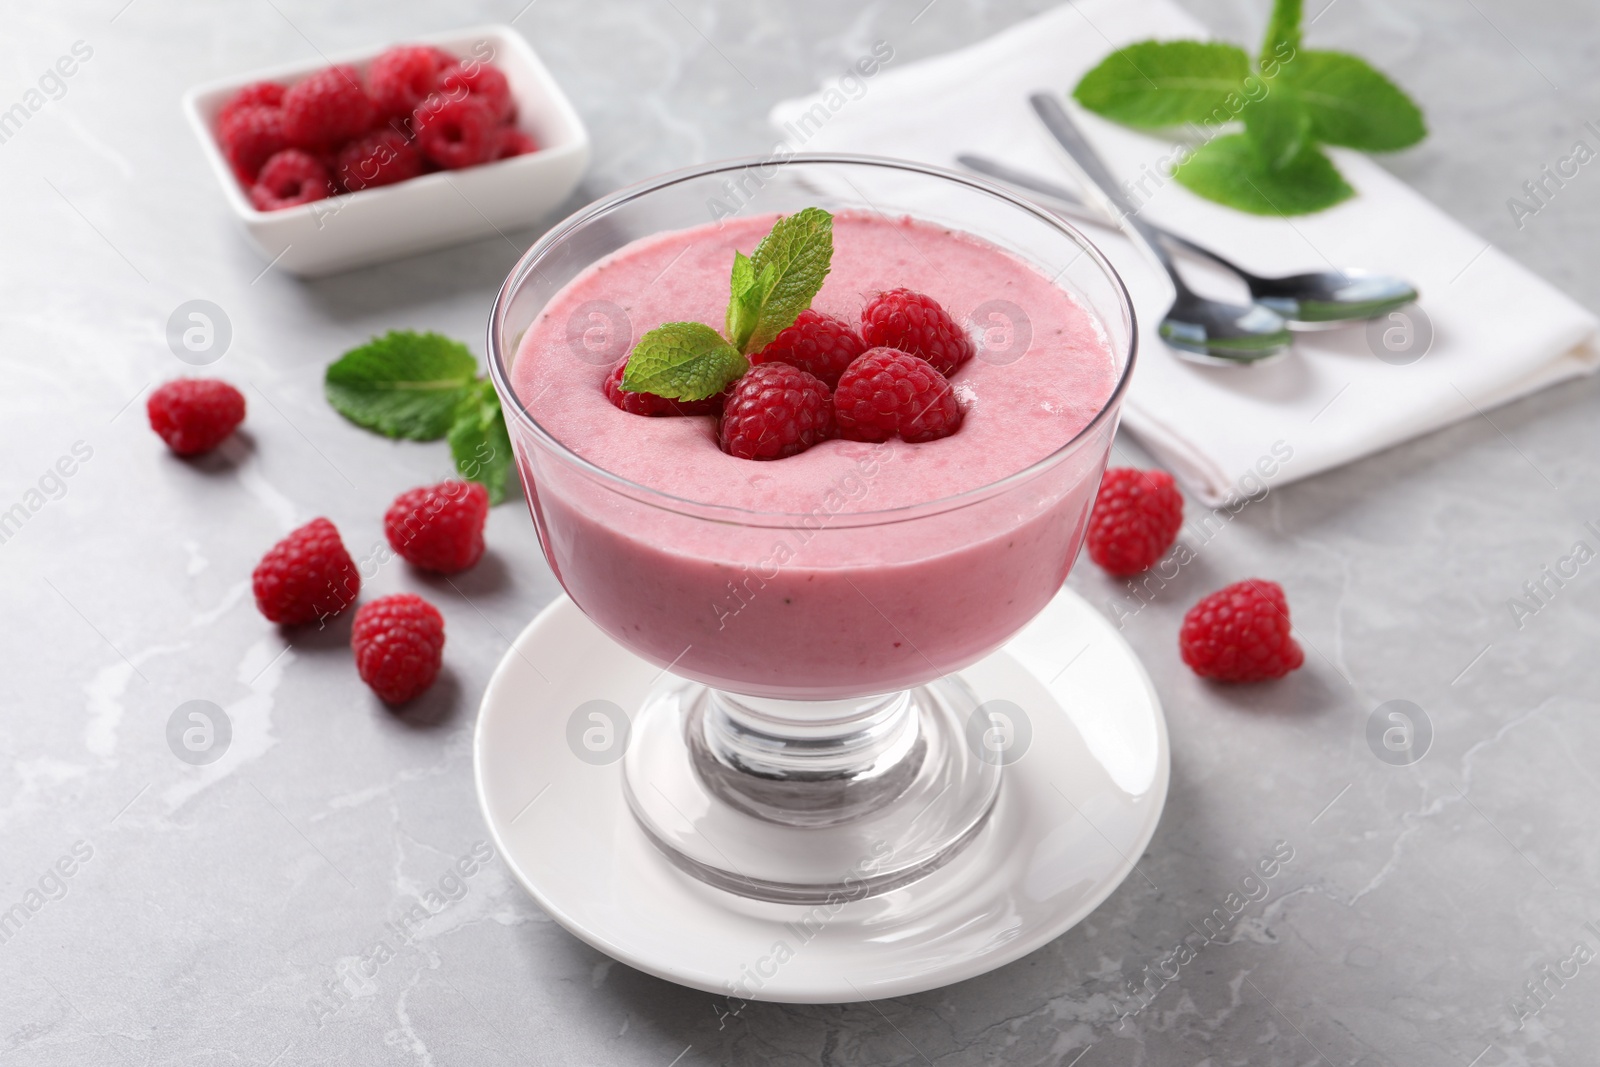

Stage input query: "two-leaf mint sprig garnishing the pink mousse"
[{"left": 621, "top": 208, "right": 834, "bottom": 400}]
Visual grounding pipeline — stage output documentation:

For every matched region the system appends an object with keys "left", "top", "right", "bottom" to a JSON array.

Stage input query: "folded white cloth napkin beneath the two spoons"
[{"left": 771, "top": 0, "right": 1600, "bottom": 506}]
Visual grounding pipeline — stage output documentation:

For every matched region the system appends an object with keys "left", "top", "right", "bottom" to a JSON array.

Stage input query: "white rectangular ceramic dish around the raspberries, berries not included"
[{"left": 184, "top": 26, "right": 589, "bottom": 277}]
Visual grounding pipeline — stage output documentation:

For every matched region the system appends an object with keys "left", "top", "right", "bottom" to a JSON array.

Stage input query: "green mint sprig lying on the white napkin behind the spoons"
[{"left": 1072, "top": 0, "right": 1427, "bottom": 214}]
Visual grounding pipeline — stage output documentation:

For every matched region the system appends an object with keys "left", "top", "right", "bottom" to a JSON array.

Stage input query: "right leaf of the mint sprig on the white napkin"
[{"left": 1283, "top": 51, "right": 1427, "bottom": 152}]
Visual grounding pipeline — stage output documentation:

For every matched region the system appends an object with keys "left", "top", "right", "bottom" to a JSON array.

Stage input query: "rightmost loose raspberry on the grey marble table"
[{"left": 1178, "top": 577, "right": 1306, "bottom": 681}]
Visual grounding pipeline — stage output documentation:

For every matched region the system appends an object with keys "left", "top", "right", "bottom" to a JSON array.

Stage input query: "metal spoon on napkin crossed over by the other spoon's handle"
[{"left": 955, "top": 154, "right": 1418, "bottom": 330}]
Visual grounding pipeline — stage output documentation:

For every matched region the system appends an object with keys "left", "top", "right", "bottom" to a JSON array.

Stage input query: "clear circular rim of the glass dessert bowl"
[{"left": 486, "top": 152, "right": 1139, "bottom": 526}]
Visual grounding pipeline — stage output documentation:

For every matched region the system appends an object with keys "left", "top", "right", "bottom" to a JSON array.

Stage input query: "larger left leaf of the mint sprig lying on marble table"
[{"left": 323, "top": 330, "right": 478, "bottom": 442}]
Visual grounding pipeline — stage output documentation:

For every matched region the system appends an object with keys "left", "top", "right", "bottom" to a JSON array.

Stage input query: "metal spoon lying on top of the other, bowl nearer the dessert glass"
[{"left": 1027, "top": 93, "right": 1291, "bottom": 366}]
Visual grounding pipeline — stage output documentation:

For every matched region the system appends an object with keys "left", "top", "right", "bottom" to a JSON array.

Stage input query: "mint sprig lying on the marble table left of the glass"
[{"left": 323, "top": 330, "right": 512, "bottom": 504}]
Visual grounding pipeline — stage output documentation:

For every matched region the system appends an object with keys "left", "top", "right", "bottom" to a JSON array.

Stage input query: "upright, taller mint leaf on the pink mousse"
[{"left": 730, "top": 208, "right": 834, "bottom": 352}]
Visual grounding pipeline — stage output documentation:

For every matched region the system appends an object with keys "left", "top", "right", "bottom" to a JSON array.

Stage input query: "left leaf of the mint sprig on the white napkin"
[{"left": 1072, "top": 40, "right": 1250, "bottom": 130}]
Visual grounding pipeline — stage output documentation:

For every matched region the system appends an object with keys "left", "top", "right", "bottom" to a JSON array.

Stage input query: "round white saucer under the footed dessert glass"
[{"left": 474, "top": 590, "right": 1168, "bottom": 1003}]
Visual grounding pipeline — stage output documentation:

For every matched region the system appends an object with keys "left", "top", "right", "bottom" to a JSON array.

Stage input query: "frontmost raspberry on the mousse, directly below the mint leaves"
[{"left": 717, "top": 363, "right": 834, "bottom": 459}]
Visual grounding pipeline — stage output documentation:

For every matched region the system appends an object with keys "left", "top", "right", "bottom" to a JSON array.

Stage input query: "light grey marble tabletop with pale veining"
[{"left": 0, "top": 0, "right": 1600, "bottom": 1067}]
